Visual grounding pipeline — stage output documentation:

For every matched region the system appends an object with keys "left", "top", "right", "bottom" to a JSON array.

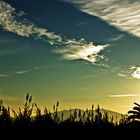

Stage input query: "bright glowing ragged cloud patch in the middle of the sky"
[{"left": 55, "top": 39, "right": 108, "bottom": 64}]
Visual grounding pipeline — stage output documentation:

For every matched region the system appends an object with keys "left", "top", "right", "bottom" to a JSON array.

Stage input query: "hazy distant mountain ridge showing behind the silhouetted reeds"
[{"left": 58, "top": 108, "right": 123, "bottom": 122}]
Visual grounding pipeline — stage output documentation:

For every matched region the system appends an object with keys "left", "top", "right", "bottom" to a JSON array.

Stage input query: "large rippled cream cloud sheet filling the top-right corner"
[{"left": 64, "top": 0, "right": 140, "bottom": 37}]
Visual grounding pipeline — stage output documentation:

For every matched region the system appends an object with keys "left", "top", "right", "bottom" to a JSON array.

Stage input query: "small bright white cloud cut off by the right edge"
[{"left": 130, "top": 66, "right": 140, "bottom": 79}]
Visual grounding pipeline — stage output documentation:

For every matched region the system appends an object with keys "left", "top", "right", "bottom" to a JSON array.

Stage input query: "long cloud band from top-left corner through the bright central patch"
[{"left": 0, "top": 1, "right": 108, "bottom": 64}]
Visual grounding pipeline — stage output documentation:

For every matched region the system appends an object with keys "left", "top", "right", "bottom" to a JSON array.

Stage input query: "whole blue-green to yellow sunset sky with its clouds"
[{"left": 0, "top": 0, "right": 140, "bottom": 113}]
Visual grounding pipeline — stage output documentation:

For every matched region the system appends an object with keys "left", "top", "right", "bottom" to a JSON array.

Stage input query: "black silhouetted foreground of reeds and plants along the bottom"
[{"left": 0, "top": 94, "right": 140, "bottom": 140}]
